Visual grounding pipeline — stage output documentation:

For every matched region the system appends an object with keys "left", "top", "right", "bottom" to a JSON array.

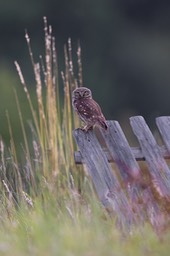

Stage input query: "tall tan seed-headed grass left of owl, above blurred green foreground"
[{"left": 1, "top": 18, "right": 84, "bottom": 210}]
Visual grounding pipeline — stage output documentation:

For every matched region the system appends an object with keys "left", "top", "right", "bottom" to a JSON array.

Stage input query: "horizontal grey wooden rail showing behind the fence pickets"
[{"left": 74, "top": 145, "right": 170, "bottom": 164}]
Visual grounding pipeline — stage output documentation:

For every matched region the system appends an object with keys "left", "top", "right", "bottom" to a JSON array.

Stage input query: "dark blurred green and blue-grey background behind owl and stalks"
[{"left": 0, "top": 0, "right": 170, "bottom": 144}]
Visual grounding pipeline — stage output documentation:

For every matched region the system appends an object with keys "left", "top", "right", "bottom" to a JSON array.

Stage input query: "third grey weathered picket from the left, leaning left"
[{"left": 130, "top": 116, "right": 170, "bottom": 200}]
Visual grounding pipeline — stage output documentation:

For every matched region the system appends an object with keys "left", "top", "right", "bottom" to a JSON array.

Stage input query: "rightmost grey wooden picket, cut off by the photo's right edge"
[{"left": 156, "top": 116, "right": 170, "bottom": 154}]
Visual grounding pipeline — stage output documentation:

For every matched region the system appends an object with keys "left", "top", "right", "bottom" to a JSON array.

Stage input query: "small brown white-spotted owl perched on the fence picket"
[{"left": 72, "top": 87, "right": 108, "bottom": 131}]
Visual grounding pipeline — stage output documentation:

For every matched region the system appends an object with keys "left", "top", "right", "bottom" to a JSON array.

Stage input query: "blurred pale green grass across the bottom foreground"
[{"left": 0, "top": 198, "right": 170, "bottom": 256}]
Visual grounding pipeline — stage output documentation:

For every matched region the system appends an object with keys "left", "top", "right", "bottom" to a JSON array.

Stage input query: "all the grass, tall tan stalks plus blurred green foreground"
[{"left": 0, "top": 18, "right": 170, "bottom": 256}]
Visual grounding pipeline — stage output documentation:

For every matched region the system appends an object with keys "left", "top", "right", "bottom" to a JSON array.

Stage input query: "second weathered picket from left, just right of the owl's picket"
[{"left": 100, "top": 121, "right": 145, "bottom": 221}]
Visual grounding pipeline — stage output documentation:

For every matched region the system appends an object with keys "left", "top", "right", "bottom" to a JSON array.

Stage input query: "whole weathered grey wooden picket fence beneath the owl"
[{"left": 73, "top": 116, "right": 170, "bottom": 233}]
